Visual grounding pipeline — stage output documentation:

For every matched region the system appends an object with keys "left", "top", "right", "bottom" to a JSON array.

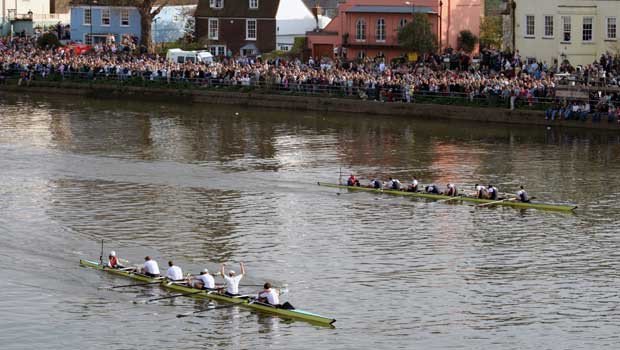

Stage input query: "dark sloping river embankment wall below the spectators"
[{"left": 0, "top": 81, "right": 620, "bottom": 130}]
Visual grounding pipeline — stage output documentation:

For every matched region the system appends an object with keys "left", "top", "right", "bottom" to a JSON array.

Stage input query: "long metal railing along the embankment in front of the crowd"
[{"left": 0, "top": 69, "right": 555, "bottom": 110}]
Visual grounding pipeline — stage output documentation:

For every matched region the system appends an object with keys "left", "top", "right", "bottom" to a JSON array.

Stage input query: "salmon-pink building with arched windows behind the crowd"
[{"left": 308, "top": 0, "right": 484, "bottom": 60}]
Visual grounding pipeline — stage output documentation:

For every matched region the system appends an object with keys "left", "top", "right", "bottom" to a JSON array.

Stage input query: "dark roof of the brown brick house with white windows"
[{"left": 195, "top": 0, "right": 278, "bottom": 19}]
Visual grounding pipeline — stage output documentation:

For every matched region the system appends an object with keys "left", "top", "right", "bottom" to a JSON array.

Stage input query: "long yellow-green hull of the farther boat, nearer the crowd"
[{"left": 318, "top": 182, "right": 577, "bottom": 212}]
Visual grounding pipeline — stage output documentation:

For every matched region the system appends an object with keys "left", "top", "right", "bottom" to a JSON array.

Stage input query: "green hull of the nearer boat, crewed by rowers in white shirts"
[{"left": 80, "top": 259, "right": 336, "bottom": 326}]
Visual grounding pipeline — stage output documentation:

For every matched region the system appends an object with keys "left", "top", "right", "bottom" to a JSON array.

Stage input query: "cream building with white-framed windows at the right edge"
[{"left": 514, "top": 0, "right": 620, "bottom": 65}]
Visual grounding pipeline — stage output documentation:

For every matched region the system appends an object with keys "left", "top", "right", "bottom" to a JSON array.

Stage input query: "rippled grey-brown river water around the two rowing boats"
[{"left": 0, "top": 91, "right": 620, "bottom": 349}]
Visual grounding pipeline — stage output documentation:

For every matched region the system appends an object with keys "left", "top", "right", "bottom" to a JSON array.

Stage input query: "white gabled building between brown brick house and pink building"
[{"left": 276, "top": 0, "right": 332, "bottom": 51}]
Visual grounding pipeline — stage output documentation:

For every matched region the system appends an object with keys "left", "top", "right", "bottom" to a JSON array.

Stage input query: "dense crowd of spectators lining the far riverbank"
[{"left": 0, "top": 34, "right": 620, "bottom": 114}]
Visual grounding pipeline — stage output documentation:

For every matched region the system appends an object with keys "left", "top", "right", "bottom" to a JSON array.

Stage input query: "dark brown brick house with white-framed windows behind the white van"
[{"left": 195, "top": 0, "right": 280, "bottom": 56}]
